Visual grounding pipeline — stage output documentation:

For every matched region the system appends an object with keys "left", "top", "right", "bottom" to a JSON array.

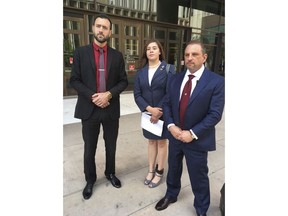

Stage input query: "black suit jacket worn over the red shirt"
[{"left": 70, "top": 44, "right": 128, "bottom": 120}]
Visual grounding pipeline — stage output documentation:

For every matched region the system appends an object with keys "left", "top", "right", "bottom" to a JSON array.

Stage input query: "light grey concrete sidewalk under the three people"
[{"left": 63, "top": 93, "right": 225, "bottom": 216}]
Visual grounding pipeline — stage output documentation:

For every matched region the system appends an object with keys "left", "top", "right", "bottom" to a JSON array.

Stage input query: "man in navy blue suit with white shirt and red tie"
[{"left": 155, "top": 41, "right": 224, "bottom": 216}]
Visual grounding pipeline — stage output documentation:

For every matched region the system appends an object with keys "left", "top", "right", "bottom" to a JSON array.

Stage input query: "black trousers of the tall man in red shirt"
[{"left": 82, "top": 111, "right": 119, "bottom": 183}]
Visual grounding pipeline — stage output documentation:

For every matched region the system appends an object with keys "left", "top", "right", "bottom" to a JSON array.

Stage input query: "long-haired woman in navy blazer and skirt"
[{"left": 134, "top": 39, "right": 175, "bottom": 188}]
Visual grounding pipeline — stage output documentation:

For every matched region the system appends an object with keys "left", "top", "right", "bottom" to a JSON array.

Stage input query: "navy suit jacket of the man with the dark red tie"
[{"left": 164, "top": 68, "right": 225, "bottom": 151}]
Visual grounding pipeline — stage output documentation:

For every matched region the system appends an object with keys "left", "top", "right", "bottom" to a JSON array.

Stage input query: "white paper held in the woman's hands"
[{"left": 141, "top": 112, "right": 164, "bottom": 136}]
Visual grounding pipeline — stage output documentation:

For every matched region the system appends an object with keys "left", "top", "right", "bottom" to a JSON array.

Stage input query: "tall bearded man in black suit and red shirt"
[{"left": 70, "top": 14, "right": 128, "bottom": 199}]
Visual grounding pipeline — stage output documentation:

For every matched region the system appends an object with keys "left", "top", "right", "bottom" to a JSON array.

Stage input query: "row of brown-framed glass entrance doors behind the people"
[{"left": 63, "top": 14, "right": 191, "bottom": 97}]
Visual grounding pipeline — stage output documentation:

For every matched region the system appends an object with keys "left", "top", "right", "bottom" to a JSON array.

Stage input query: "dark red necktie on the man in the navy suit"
[{"left": 179, "top": 75, "right": 195, "bottom": 128}]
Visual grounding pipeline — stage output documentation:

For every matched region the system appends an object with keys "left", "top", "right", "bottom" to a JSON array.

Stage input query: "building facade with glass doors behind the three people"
[{"left": 63, "top": 0, "right": 225, "bottom": 98}]
